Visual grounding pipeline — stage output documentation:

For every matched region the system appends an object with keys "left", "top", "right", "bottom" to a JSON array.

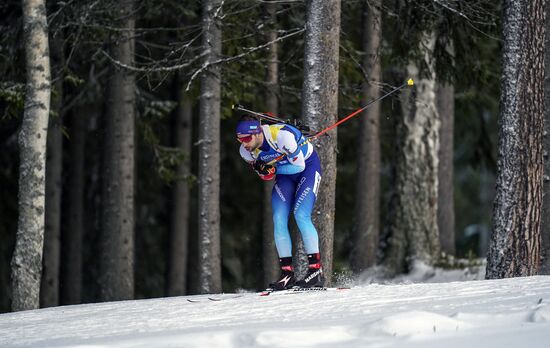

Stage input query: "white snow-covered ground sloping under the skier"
[{"left": 0, "top": 274, "right": 550, "bottom": 348}]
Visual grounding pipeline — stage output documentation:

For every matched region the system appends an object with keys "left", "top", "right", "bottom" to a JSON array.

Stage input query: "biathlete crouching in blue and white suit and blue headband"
[{"left": 236, "top": 115, "right": 324, "bottom": 290}]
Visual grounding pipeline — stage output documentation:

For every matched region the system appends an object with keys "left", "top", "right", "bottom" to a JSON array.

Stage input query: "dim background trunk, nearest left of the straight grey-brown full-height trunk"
[{"left": 61, "top": 105, "right": 88, "bottom": 304}]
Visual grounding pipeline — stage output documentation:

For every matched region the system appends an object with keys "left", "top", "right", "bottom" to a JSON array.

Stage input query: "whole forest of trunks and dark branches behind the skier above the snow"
[{"left": 0, "top": 0, "right": 550, "bottom": 313}]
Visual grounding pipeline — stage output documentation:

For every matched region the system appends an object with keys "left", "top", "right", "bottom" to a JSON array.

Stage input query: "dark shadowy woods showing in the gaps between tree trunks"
[{"left": 0, "top": 0, "right": 501, "bottom": 312}]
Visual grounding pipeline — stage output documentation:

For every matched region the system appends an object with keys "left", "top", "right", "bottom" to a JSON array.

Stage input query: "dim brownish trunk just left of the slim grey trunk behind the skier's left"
[{"left": 168, "top": 75, "right": 193, "bottom": 296}]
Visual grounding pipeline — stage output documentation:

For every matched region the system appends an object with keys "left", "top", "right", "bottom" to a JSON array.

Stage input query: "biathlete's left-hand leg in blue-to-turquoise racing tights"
[{"left": 271, "top": 175, "right": 295, "bottom": 258}]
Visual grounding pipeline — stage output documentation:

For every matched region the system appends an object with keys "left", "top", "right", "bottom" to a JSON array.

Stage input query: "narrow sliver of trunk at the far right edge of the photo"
[{"left": 539, "top": 1, "right": 550, "bottom": 274}]
